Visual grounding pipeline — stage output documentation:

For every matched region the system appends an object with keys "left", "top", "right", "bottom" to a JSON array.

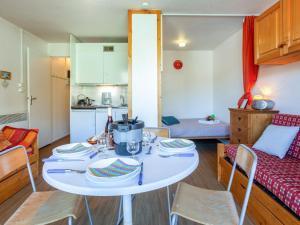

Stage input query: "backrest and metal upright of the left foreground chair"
[{"left": 0, "top": 145, "right": 36, "bottom": 192}]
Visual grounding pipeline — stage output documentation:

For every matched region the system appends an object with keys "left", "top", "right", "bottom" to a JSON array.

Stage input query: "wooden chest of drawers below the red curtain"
[{"left": 229, "top": 108, "right": 278, "bottom": 144}]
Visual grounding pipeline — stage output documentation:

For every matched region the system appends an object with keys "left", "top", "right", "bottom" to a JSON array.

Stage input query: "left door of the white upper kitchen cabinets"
[{"left": 75, "top": 43, "right": 103, "bottom": 84}]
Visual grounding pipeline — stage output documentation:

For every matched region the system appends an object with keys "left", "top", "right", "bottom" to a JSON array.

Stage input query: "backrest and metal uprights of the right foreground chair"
[{"left": 227, "top": 145, "right": 257, "bottom": 225}]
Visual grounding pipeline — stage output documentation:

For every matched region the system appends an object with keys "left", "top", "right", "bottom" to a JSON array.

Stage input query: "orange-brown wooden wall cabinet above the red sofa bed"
[{"left": 255, "top": 0, "right": 300, "bottom": 64}]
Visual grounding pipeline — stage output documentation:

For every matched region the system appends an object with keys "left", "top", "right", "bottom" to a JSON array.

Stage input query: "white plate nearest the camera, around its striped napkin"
[{"left": 86, "top": 157, "right": 140, "bottom": 183}]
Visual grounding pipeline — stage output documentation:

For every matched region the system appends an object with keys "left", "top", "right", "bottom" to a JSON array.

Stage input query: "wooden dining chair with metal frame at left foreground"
[{"left": 0, "top": 146, "right": 91, "bottom": 225}]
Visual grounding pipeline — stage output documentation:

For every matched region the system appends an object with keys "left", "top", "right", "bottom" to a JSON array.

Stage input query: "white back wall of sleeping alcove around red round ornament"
[{"left": 162, "top": 51, "right": 213, "bottom": 118}]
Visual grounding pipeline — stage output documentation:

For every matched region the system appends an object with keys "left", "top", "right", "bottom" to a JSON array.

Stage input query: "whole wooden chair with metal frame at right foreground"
[{"left": 171, "top": 145, "right": 257, "bottom": 225}]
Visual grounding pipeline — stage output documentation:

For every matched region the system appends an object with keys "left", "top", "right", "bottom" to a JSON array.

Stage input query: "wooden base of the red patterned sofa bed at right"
[{"left": 217, "top": 144, "right": 300, "bottom": 225}]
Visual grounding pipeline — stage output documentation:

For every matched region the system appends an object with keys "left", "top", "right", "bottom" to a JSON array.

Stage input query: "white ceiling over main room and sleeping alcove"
[{"left": 0, "top": 0, "right": 277, "bottom": 49}]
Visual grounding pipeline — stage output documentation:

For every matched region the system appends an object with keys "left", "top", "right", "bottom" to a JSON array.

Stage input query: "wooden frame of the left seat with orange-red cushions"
[{"left": 0, "top": 141, "right": 39, "bottom": 204}]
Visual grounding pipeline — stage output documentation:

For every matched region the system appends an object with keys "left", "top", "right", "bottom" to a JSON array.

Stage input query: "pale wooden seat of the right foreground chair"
[{"left": 171, "top": 183, "right": 239, "bottom": 225}]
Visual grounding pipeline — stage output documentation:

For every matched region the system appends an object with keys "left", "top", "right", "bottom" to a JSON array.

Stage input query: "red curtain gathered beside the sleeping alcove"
[{"left": 238, "top": 16, "right": 259, "bottom": 107}]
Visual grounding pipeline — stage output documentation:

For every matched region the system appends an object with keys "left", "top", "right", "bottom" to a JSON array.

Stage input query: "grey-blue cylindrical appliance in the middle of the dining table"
[{"left": 111, "top": 117, "right": 144, "bottom": 156}]
